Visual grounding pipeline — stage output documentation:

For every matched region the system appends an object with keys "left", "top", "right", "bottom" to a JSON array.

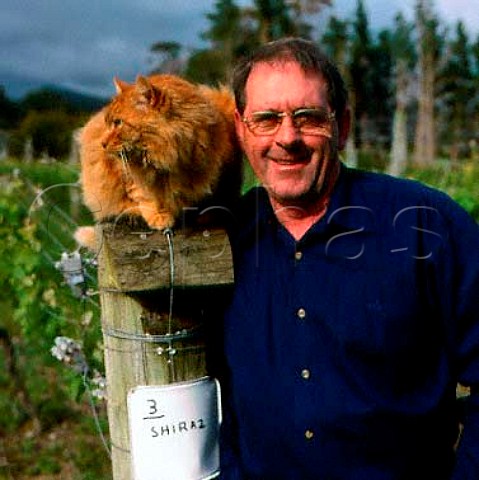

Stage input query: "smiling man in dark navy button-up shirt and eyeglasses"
[{"left": 221, "top": 39, "right": 479, "bottom": 480}]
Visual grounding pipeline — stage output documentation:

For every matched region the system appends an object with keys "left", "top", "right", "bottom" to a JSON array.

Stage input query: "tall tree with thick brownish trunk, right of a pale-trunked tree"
[{"left": 414, "top": 0, "right": 440, "bottom": 166}]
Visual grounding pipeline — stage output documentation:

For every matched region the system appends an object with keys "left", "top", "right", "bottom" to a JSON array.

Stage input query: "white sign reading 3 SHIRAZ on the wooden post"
[{"left": 128, "top": 377, "right": 221, "bottom": 480}]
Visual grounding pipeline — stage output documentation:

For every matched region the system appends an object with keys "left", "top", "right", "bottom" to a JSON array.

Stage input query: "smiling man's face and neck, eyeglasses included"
[{"left": 236, "top": 47, "right": 349, "bottom": 239}]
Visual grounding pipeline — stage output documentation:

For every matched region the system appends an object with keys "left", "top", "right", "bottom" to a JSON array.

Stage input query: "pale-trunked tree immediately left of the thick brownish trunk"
[{"left": 388, "top": 14, "right": 415, "bottom": 175}]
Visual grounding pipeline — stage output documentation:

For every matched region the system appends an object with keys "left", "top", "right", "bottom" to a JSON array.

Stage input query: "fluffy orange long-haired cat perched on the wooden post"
[{"left": 75, "top": 75, "right": 241, "bottom": 251}]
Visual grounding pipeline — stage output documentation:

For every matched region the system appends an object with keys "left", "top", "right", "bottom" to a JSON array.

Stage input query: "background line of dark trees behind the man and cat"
[{"left": 0, "top": 0, "right": 479, "bottom": 175}]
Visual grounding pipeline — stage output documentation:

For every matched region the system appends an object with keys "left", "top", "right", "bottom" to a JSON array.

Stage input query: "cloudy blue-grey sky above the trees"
[{"left": 0, "top": 0, "right": 479, "bottom": 98}]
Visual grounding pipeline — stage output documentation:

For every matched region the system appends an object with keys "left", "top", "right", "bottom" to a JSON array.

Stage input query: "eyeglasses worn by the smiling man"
[{"left": 241, "top": 108, "right": 336, "bottom": 137}]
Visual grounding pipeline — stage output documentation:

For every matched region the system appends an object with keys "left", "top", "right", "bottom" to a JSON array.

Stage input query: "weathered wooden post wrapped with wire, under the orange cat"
[{"left": 97, "top": 223, "right": 233, "bottom": 480}]
